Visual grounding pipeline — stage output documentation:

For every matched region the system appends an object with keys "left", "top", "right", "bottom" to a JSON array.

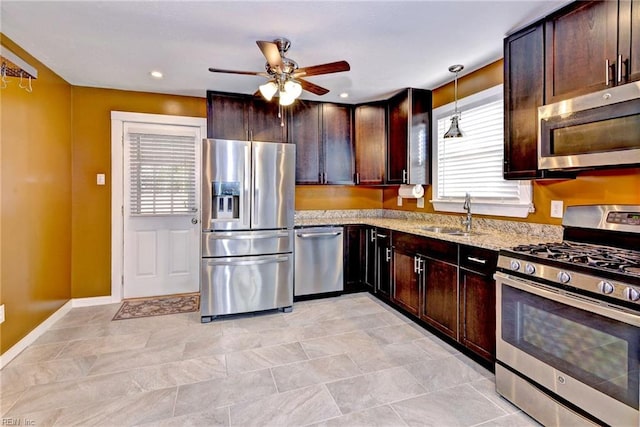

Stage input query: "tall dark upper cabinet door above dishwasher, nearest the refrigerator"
[{"left": 288, "top": 100, "right": 321, "bottom": 184}]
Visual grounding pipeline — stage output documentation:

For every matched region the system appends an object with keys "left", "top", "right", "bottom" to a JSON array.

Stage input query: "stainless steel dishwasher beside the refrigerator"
[{"left": 293, "top": 227, "right": 344, "bottom": 296}]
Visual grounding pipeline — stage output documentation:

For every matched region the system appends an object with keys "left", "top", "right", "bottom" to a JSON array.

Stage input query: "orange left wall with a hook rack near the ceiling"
[{"left": 0, "top": 34, "right": 71, "bottom": 353}]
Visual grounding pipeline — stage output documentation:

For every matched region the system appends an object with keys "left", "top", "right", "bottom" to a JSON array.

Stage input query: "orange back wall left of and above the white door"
[{"left": 71, "top": 86, "right": 207, "bottom": 298}]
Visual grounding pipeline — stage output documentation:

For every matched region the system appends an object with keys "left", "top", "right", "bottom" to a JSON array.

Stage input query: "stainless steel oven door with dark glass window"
[{"left": 494, "top": 272, "right": 640, "bottom": 426}]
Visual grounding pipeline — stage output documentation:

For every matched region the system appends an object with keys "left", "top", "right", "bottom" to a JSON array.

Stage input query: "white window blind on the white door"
[{"left": 128, "top": 132, "right": 196, "bottom": 215}]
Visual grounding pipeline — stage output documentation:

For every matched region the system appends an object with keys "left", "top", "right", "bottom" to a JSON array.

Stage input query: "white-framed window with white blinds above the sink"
[{"left": 432, "top": 85, "right": 532, "bottom": 217}]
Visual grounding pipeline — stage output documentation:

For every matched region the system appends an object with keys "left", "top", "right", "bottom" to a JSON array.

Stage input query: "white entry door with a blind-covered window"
[{"left": 123, "top": 122, "right": 203, "bottom": 298}]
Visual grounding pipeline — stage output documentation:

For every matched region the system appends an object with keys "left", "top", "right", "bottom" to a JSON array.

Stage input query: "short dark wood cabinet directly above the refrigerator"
[{"left": 207, "top": 91, "right": 287, "bottom": 142}]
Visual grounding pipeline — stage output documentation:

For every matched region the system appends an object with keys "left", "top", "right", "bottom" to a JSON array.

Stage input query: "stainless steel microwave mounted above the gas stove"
[{"left": 538, "top": 82, "right": 640, "bottom": 170}]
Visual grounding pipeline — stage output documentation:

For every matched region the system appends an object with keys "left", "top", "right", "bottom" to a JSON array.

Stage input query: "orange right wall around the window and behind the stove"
[{"left": 383, "top": 60, "right": 640, "bottom": 224}]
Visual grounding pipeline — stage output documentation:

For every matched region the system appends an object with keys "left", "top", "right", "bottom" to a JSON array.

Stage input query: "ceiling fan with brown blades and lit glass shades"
[{"left": 209, "top": 37, "right": 351, "bottom": 105}]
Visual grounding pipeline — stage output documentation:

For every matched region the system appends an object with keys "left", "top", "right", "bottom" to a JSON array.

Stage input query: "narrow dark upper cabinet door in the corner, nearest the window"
[{"left": 387, "top": 90, "right": 409, "bottom": 184}]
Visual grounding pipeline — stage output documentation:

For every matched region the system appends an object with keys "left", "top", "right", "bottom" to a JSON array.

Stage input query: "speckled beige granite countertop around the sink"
[{"left": 295, "top": 209, "right": 562, "bottom": 250}]
